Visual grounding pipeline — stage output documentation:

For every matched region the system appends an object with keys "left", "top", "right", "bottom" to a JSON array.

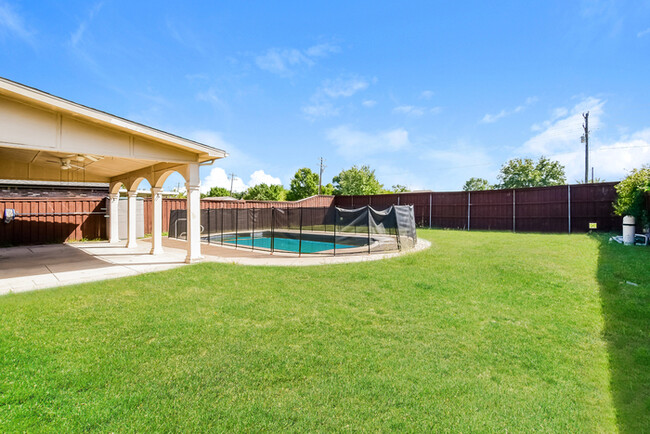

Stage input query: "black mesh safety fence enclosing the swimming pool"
[{"left": 168, "top": 205, "right": 417, "bottom": 255}]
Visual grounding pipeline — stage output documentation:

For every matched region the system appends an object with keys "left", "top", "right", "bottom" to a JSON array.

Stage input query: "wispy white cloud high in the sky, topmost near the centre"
[{"left": 255, "top": 43, "right": 340, "bottom": 77}]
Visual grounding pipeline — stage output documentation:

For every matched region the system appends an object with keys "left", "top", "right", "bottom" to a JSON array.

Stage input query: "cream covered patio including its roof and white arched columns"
[{"left": 0, "top": 77, "right": 227, "bottom": 263}]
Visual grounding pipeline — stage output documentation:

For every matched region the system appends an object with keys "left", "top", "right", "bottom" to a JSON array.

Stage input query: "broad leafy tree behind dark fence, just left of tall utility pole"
[{"left": 496, "top": 157, "right": 566, "bottom": 188}]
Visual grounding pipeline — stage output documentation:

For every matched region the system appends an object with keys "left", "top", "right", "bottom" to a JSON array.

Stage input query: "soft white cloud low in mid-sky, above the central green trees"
[{"left": 327, "top": 125, "right": 410, "bottom": 160}]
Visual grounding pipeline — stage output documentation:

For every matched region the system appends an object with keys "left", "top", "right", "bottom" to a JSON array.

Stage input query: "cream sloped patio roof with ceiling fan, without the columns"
[{"left": 0, "top": 77, "right": 227, "bottom": 185}]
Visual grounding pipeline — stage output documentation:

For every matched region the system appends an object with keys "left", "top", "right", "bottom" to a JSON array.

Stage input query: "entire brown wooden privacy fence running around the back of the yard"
[{"left": 0, "top": 183, "right": 636, "bottom": 245}]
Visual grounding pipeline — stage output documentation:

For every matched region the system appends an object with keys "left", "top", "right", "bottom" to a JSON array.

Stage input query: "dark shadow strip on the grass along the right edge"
[{"left": 597, "top": 235, "right": 650, "bottom": 433}]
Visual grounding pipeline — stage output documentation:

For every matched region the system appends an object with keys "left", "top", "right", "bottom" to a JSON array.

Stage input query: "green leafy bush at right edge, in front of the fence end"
[{"left": 614, "top": 166, "right": 650, "bottom": 227}]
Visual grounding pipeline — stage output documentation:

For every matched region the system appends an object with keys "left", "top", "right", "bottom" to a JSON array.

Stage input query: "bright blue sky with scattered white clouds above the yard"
[{"left": 0, "top": 0, "right": 650, "bottom": 191}]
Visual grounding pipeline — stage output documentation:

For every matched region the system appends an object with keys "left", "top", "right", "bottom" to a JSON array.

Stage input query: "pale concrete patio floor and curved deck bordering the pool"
[{"left": 0, "top": 238, "right": 431, "bottom": 295}]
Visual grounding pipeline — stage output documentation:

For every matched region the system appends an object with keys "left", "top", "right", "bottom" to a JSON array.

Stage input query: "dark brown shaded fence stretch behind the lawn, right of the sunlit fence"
[{"left": 335, "top": 182, "right": 621, "bottom": 233}]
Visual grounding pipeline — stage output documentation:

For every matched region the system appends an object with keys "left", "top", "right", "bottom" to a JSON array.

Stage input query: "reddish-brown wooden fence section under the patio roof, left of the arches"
[{"left": 0, "top": 198, "right": 106, "bottom": 245}]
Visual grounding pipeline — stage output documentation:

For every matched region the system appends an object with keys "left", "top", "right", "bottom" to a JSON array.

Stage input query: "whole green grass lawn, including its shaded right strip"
[{"left": 0, "top": 230, "right": 650, "bottom": 432}]
